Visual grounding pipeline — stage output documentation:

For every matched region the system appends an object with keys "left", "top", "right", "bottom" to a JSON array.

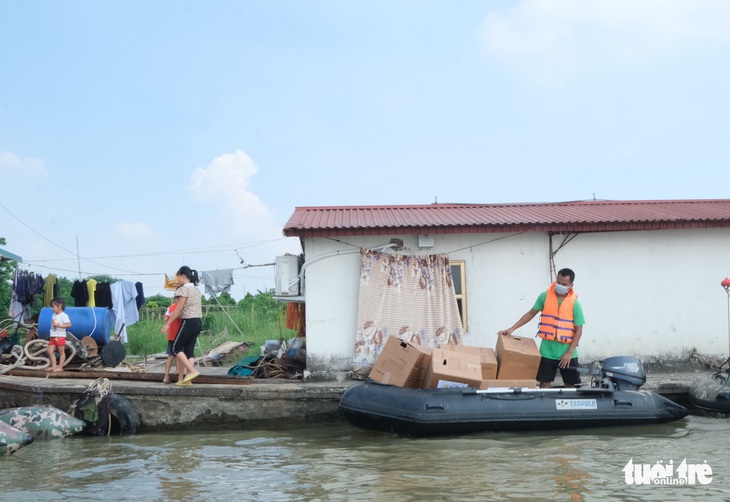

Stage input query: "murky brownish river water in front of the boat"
[{"left": 0, "top": 416, "right": 730, "bottom": 502}]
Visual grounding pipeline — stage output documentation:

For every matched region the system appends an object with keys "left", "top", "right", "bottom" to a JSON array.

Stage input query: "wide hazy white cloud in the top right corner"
[{"left": 480, "top": 0, "right": 730, "bottom": 81}]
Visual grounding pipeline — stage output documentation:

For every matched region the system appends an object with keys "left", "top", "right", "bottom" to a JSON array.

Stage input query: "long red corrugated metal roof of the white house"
[{"left": 284, "top": 199, "right": 730, "bottom": 237}]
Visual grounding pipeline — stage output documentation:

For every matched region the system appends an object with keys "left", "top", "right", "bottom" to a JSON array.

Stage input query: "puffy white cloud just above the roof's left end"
[{"left": 189, "top": 149, "right": 281, "bottom": 235}]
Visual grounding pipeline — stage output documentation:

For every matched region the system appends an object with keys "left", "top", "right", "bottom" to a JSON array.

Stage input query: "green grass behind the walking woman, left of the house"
[{"left": 126, "top": 305, "right": 297, "bottom": 364}]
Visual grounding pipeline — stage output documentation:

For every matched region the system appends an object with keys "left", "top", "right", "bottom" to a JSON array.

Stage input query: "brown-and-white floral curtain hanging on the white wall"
[{"left": 353, "top": 249, "right": 463, "bottom": 378}]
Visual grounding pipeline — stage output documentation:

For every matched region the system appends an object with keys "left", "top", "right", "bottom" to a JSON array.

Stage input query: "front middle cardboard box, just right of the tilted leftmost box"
[{"left": 422, "top": 349, "right": 482, "bottom": 389}]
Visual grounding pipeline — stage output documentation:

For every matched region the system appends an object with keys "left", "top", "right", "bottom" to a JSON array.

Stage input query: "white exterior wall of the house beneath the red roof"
[{"left": 304, "top": 229, "right": 730, "bottom": 374}]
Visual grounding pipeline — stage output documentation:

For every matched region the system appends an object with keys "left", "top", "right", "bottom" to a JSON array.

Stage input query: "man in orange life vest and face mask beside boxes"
[{"left": 498, "top": 268, "right": 585, "bottom": 388}]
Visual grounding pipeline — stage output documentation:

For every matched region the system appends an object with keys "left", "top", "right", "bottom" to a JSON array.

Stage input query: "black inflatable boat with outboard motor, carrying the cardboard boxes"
[{"left": 340, "top": 357, "right": 688, "bottom": 436}]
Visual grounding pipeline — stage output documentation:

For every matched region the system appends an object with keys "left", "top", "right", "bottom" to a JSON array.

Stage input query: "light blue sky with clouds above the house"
[{"left": 0, "top": 0, "right": 730, "bottom": 298}]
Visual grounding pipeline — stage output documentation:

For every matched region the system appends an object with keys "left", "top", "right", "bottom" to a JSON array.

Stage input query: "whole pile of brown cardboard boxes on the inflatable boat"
[{"left": 370, "top": 336, "right": 540, "bottom": 389}]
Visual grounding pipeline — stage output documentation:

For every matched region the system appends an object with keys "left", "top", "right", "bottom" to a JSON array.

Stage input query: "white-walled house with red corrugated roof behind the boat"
[{"left": 283, "top": 200, "right": 730, "bottom": 378}]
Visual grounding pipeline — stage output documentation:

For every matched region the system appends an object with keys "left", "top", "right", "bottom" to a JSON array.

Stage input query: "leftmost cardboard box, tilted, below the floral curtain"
[{"left": 369, "top": 336, "right": 431, "bottom": 389}]
